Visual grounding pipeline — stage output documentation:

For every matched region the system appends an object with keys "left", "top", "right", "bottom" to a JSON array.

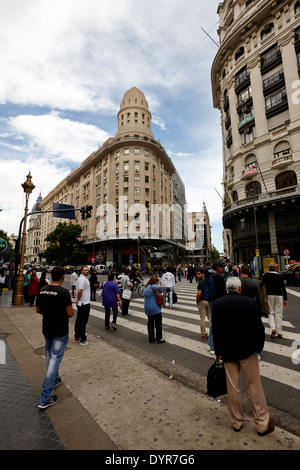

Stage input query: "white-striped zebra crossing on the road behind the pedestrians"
[{"left": 90, "top": 280, "right": 300, "bottom": 390}]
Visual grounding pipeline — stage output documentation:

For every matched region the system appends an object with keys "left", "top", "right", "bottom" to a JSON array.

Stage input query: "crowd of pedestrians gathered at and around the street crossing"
[{"left": 33, "top": 262, "right": 287, "bottom": 436}]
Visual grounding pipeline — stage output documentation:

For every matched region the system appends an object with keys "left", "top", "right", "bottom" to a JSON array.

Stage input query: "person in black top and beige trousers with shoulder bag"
[{"left": 260, "top": 263, "right": 287, "bottom": 339}]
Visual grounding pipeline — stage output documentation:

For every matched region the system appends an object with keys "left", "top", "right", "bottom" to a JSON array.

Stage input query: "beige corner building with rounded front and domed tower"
[{"left": 41, "top": 88, "right": 195, "bottom": 265}]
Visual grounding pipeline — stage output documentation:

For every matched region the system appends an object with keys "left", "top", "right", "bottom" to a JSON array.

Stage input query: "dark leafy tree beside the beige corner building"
[{"left": 43, "top": 222, "right": 87, "bottom": 266}]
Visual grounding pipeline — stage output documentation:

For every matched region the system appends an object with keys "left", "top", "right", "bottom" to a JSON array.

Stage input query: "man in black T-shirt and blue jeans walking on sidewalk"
[{"left": 36, "top": 266, "right": 74, "bottom": 410}]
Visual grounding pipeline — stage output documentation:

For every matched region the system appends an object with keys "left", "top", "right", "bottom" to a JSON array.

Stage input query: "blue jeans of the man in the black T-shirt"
[{"left": 40, "top": 335, "right": 69, "bottom": 405}]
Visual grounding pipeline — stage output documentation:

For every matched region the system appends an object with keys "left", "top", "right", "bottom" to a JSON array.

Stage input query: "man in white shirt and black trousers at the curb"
[{"left": 74, "top": 266, "right": 91, "bottom": 346}]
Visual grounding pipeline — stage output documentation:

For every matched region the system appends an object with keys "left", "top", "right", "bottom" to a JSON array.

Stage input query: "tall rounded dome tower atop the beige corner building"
[{"left": 115, "top": 87, "right": 154, "bottom": 139}]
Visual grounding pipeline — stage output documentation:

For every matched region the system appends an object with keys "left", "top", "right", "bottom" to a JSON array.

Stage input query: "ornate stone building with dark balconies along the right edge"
[{"left": 211, "top": 0, "right": 300, "bottom": 274}]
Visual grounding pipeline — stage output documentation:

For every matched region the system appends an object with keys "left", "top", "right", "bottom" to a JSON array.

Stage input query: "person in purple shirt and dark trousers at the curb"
[{"left": 101, "top": 274, "right": 122, "bottom": 330}]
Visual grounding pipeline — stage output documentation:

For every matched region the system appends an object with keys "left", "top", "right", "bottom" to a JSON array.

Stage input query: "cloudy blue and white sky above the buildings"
[{"left": 0, "top": 0, "right": 223, "bottom": 252}]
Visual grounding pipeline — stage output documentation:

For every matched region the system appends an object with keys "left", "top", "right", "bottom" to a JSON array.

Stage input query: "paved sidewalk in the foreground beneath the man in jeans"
[{"left": 0, "top": 295, "right": 300, "bottom": 451}]
